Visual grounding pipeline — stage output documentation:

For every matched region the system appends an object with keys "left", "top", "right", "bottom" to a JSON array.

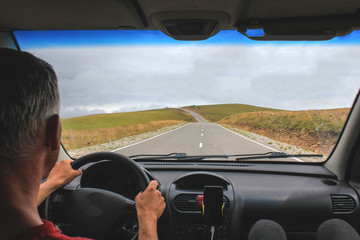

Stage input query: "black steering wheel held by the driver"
[{"left": 45, "top": 152, "right": 150, "bottom": 239}]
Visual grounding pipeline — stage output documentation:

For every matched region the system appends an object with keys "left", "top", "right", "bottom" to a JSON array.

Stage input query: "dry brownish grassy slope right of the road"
[{"left": 218, "top": 108, "right": 350, "bottom": 155}]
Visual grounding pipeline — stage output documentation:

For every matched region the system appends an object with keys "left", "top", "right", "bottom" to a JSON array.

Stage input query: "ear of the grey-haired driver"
[{"left": 45, "top": 114, "right": 61, "bottom": 151}]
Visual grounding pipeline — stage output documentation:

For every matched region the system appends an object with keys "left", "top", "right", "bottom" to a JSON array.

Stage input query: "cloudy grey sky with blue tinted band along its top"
[{"left": 15, "top": 31, "right": 360, "bottom": 118}]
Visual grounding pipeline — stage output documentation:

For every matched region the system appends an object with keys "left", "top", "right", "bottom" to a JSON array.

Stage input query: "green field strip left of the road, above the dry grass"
[{"left": 61, "top": 108, "right": 195, "bottom": 131}]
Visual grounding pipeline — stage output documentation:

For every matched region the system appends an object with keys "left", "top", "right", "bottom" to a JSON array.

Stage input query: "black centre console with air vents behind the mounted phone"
[{"left": 169, "top": 172, "right": 234, "bottom": 240}]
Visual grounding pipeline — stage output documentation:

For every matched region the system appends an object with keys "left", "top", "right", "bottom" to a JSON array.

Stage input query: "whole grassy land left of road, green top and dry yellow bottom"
[{"left": 61, "top": 108, "right": 195, "bottom": 150}]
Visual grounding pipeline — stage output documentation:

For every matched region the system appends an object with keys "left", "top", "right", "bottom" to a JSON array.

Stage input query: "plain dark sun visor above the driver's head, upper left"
[{"left": 0, "top": 0, "right": 145, "bottom": 30}]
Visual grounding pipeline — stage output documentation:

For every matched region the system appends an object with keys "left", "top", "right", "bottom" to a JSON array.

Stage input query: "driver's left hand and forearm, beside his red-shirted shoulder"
[{"left": 37, "top": 160, "right": 81, "bottom": 205}]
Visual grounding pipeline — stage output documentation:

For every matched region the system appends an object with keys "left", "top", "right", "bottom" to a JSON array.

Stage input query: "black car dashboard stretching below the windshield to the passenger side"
[{"left": 47, "top": 160, "right": 360, "bottom": 240}]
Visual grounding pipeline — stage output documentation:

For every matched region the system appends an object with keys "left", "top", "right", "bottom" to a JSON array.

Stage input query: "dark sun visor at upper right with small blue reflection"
[{"left": 237, "top": 15, "right": 360, "bottom": 41}]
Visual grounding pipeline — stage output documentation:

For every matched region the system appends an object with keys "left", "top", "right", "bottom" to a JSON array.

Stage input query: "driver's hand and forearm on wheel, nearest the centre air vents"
[{"left": 135, "top": 181, "right": 166, "bottom": 240}]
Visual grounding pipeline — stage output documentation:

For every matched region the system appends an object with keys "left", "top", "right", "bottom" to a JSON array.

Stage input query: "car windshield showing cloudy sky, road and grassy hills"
[{"left": 15, "top": 30, "right": 360, "bottom": 162}]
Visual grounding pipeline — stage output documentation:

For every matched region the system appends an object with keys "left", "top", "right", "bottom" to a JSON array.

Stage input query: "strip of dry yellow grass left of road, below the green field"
[{"left": 61, "top": 120, "right": 185, "bottom": 150}]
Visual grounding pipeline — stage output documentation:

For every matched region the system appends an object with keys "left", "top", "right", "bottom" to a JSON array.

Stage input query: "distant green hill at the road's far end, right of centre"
[{"left": 184, "top": 104, "right": 280, "bottom": 122}]
